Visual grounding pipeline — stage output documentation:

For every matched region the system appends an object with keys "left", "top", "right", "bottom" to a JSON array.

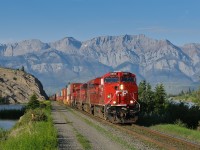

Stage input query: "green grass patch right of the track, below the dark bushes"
[{"left": 151, "top": 124, "right": 200, "bottom": 142}]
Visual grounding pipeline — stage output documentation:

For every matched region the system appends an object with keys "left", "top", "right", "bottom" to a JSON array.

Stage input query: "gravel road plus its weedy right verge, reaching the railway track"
[{"left": 52, "top": 102, "right": 152, "bottom": 150}]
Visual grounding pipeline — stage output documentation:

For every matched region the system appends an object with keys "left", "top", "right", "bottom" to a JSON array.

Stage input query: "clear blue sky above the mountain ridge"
[{"left": 0, "top": 0, "right": 200, "bottom": 45}]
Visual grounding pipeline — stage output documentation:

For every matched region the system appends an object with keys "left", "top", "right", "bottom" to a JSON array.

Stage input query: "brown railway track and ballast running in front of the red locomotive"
[{"left": 66, "top": 105, "right": 200, "bottom": 150}]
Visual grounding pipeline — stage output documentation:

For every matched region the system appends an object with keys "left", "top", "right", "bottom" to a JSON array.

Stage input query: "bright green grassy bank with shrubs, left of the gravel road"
[{"left": 0, "top": 102, "right": 57, "bottom": 150}]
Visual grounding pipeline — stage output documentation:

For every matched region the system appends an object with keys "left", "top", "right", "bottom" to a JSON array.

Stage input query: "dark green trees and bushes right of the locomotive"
[{"left": 138, "top": 80, "right": 200, "bottom": 129}]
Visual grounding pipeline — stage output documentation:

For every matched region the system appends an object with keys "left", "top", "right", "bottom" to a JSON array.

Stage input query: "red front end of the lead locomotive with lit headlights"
[{"left": 101, "top": 72, "right": 140, "bottom": 123}]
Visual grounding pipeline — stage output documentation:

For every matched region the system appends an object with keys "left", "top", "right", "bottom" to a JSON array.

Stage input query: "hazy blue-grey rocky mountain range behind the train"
[{"left": 0, "top": 34, "right": 200, "bottom": 94}]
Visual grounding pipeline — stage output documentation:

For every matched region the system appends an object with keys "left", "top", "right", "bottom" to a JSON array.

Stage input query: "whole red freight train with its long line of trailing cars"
[{"left": 53, "top": 72, "right": 140, "bottom": 123}]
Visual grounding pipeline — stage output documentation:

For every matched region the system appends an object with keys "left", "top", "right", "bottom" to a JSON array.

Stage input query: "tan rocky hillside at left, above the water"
[{"left": 0, "top": 68, "right": 47, "bottom": 104}]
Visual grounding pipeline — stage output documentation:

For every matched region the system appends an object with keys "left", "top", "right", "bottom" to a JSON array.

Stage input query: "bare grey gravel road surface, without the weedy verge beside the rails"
[{"left": 52, "top": 102, "right": 126, "bottom": 150}]
